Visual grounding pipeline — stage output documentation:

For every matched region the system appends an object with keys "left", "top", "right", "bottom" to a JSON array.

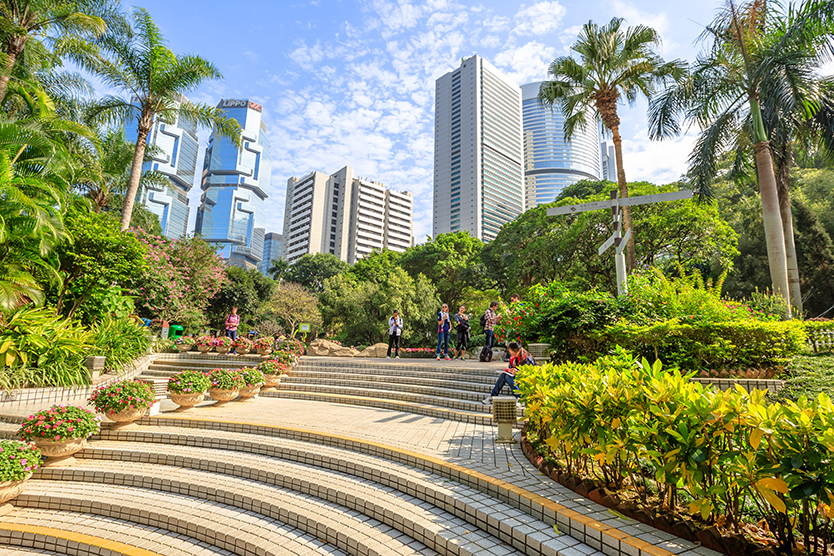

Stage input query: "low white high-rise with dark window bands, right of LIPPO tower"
[{"left": 282, "top": 166, "right": 414, "bottom": 264}]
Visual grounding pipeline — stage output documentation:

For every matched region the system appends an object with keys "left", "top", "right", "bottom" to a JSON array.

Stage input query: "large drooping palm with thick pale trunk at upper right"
[{"left": 649, "top": 0, "right": 834, "bottom": 315}]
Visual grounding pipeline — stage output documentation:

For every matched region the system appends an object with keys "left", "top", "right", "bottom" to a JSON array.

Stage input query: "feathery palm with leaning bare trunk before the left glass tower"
[{"left": 84, "top": 8, "right": 240, "bottom": 230}]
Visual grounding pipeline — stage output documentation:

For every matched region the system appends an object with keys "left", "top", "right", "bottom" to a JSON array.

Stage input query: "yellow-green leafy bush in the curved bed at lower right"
[{"left": 516, "top": 350, "right": 834, "bottom": 554}]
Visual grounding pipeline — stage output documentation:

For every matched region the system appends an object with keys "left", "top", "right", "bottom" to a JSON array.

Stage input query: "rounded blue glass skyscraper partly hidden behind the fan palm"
[{"left": 521, "top": 82, "right": 601, "bottom": 209}]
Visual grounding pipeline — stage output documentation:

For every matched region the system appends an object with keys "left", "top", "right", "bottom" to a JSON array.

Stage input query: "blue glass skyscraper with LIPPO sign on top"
[{"left": 196, "top": 99, "right": 272, "bottom": 268}]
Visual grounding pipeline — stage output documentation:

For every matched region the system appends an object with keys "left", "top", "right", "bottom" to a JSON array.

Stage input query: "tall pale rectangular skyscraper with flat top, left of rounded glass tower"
[{"left": 432, "top": 56, "right": 524, "bottom": 241}]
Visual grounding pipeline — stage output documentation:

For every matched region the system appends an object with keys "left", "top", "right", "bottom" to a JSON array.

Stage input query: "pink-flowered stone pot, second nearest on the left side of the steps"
[{"left": 17, "top": 405, "right": 101, "bottom": 467}]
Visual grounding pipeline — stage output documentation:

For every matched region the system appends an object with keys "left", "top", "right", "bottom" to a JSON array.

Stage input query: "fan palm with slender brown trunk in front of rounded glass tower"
[{"left": 539, "top": 17, "right": 686, "bottom": 270}]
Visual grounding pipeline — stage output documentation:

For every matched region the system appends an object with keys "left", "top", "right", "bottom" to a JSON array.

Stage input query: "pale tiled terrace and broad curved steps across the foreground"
[{"left": 0, "top": 358, "right": 714, "bottom": 556}]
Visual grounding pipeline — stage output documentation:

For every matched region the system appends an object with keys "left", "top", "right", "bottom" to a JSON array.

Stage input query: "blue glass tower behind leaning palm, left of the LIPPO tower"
[{"left": 125, "top": 97, "right": 198, "bottom": 238}]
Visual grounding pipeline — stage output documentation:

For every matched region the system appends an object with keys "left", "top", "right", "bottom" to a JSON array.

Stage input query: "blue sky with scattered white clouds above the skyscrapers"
[{"left": 125, "top": 0, "right": 718, "bottom": 242}]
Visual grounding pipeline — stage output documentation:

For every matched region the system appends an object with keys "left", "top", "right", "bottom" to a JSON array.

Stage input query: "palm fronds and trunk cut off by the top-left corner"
[{"left": 0, "top": 0, "right": 114, "bottom": 102}]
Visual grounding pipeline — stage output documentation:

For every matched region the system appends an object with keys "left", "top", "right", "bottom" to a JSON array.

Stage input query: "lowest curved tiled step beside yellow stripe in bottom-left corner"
[{"left": 0, "top": 508, "right": 234, "bottom": 556}]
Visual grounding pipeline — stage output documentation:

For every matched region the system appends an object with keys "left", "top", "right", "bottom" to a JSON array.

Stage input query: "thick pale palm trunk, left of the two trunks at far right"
[{"left": 754, "top": 141, "right": 791, "bottom": 318}]
